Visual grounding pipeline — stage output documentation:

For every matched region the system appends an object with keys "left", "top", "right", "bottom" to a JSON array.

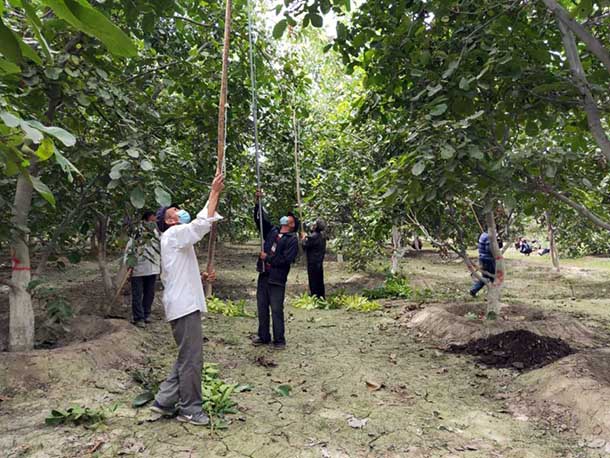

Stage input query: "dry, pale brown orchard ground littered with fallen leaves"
[{"left": 0, "top": 244, "right": 610, "bottom": 458}]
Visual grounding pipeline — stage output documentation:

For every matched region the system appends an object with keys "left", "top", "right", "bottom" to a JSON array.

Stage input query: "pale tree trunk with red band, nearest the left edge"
[{"left": 9, "top": 175, "right": 34, "bottom": 351}]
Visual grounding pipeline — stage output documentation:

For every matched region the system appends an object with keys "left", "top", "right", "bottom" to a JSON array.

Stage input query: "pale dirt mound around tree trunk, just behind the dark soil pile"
[{"left": 399, "top": 303, "right": 608, "bottom": 349}]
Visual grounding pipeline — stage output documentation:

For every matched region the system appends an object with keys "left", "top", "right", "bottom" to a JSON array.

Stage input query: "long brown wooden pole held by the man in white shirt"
[{"left": 205, "top": 0, "right": 231, "bottom": 297}]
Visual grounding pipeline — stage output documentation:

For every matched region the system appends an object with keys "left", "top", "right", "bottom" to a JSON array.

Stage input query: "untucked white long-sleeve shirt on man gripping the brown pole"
[{"left": 161, "top": 204, "right": 222, "bottom": 321}]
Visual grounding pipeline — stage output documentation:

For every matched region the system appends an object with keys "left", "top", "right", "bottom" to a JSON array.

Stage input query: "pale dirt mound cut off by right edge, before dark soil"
[{"left": 512, "top": 348, "right": 610, "bottom": 440}]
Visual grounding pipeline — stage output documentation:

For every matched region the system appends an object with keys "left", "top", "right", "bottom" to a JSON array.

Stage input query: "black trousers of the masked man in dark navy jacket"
[{"left": 256, "top": 274, "right": 286, "bottom": 344}]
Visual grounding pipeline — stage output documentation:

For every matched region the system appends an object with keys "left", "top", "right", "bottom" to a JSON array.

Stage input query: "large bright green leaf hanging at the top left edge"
[{"left": 44, "top": 0, "right": 138, "bottom": 57}]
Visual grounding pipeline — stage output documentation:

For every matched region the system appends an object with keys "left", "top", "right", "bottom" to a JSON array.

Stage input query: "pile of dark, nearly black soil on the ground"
[{"left": 448, "top": 329, "right": 574, "bottom": 370}]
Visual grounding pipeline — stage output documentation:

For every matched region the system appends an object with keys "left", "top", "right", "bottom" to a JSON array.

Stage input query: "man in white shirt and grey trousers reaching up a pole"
[{"left": 151, "top": 174, "right": 224, "bottom": 426}]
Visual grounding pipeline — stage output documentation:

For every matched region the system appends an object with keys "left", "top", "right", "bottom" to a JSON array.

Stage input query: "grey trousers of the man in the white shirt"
[{"left": 156, "top": 311, "right": 203, "bottom": 415}]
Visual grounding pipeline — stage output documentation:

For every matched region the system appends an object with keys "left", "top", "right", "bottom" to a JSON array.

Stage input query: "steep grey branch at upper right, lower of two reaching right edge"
[{"left": 557, "top": 20, "right": 610, "bottom": 160}]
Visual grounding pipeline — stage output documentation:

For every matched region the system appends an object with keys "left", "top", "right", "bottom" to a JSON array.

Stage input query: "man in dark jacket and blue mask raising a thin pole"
[{"left": 252, "top": 192, "right": 299, "bottom": 349}]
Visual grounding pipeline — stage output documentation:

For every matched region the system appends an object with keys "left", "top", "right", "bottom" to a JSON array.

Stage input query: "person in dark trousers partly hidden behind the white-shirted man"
[{"left": 125, "top": 211, "right": 161, "bottom": 328}]
